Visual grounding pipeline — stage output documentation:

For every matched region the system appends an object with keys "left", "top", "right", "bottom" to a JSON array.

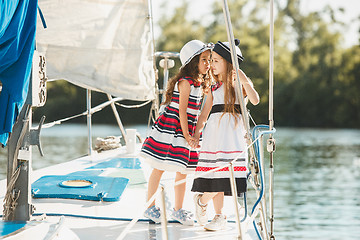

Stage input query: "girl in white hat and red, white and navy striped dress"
[{"left": 140, "top": 40, "right": 211, "bottom": 225}]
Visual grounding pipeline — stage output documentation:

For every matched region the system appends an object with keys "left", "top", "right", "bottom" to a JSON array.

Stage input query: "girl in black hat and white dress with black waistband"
[{"left": 192, "top": 40, "right": 259, "bottom": 231}]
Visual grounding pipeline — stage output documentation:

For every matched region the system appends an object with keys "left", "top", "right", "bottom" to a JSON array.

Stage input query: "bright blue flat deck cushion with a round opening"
[{"left": 31, "top": 174, "right": 129, "bottom": 202}]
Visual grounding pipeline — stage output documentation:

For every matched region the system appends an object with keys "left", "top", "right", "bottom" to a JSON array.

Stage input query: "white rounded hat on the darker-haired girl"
[{"left": 180, "top": 40, "right": 212, "bottom": 67}]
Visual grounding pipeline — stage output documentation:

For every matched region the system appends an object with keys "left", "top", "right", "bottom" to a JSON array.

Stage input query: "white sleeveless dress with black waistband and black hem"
[{"left": 191, "top": 84, "right": 248, "bottom": 196}]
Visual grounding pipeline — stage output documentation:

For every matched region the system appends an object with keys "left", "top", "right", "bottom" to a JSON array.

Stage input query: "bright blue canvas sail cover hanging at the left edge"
[{"left": 0, "top": 0, "right": 37, "bottom": 146}]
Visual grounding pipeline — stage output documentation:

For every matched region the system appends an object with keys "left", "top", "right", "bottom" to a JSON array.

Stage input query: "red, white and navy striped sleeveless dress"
[{"left": 140, "top": 77, "right": 202, "bottom": 174}]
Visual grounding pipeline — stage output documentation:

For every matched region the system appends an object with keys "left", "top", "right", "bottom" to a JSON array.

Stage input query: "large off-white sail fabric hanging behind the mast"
[{"left": 36, "top": 0, "right": 155, "bottom": 100}]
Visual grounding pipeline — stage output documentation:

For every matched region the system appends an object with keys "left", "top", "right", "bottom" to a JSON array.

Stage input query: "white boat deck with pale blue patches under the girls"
[{"left": 0, "top": 146, "right": 257, "bottom": 240}]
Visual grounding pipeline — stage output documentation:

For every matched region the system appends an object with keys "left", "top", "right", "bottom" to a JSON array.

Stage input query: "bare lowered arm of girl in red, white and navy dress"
[{"left": 178, "top": 80, "right": 194, "bottom": 144}]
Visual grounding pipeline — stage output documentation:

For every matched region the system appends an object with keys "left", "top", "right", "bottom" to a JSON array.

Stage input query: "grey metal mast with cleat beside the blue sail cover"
[{"left": 3, "top": 51, "right": 47, "bottom": 221}]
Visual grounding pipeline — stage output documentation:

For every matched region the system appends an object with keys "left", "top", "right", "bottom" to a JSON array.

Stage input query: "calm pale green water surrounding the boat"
[{"left": 0, "top": 125, "right": 360, "bottom": 240}]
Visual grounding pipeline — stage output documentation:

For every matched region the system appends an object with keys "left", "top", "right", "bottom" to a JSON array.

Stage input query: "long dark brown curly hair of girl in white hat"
[{"left": 162, "top": 54, "right": 210, "bottom": 104}]
